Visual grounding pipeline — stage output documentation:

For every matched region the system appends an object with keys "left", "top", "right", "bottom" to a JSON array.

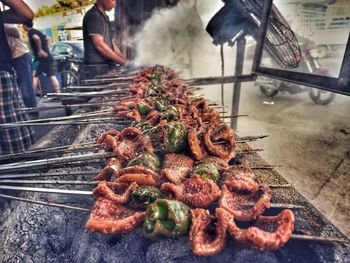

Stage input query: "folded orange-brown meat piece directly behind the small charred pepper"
[{"left": 117, "top": 165, "right": 164, "bottom": 186}]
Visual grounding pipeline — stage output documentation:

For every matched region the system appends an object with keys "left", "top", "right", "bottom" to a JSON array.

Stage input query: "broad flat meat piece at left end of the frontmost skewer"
[{"left": 85, "top": 198, "right": 146, "bottom": 234}]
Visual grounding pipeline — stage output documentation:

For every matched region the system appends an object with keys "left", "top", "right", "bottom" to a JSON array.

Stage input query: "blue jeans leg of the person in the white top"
[{"left": 14, "top": 54, "right": 36, "bottom": 107}]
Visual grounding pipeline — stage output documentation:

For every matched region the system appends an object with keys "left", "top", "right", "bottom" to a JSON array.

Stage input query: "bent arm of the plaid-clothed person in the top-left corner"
[{"left": 0, "top": 0, "right": 34, "bottom": 24}]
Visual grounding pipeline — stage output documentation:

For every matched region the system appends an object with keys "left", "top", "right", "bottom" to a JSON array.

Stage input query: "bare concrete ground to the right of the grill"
[{"left": 203, "top": 83, "right": 350, "bottom": 237}]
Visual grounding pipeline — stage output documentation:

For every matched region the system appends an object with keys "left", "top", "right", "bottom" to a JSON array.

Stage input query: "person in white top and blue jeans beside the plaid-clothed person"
[{"left": 5, "top": 24, "right": 36, "bottom": 112}]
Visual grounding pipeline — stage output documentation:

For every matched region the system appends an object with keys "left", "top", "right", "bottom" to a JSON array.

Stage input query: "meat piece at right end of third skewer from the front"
[{"left": 221, "top": 165, "right": 260, "bottom": 193}]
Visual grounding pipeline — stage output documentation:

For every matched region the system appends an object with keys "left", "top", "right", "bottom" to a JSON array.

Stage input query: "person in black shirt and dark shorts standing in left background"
[{"left": 23, "top": 25, "right": 60, "bottom": 93}]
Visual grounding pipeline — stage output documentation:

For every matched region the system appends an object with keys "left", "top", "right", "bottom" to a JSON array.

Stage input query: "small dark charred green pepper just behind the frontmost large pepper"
[{"left": 130, "top": 185, "right": 165, "bottom": 208}]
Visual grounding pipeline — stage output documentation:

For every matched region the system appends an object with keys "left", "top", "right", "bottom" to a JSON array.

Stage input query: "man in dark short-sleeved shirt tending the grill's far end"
[{"left": 83, "top": 0, "right": 127, "bottom": 78}]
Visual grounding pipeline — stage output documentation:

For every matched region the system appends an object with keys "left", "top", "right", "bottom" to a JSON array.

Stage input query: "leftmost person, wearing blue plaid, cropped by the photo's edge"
[{"left": 0, "top": 0, "right": 34, "bottom": 154}]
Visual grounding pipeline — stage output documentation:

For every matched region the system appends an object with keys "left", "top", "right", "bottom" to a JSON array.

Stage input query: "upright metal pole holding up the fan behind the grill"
[{"left": 231, "top": 35, "right": 246, "bottom": 130}]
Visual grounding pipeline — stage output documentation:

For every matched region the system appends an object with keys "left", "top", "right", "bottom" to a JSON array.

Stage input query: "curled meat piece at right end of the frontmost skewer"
[{"left": 228, "top": 209, "right": 294, "bottom": 251}]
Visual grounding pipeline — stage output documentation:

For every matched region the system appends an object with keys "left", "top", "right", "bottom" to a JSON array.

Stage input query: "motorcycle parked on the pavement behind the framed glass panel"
[{"left": 255, "top": 41, "right": 335, "bottom": 105}]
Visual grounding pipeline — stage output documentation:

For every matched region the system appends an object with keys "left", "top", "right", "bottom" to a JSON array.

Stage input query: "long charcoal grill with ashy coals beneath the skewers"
[{"left": 0, "top": 0, "right": 350, "bottom": 262}]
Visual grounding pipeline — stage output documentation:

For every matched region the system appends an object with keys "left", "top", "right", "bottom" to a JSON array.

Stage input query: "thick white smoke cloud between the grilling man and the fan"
[{"left": 134, "top": 0, "right": 238, "bottom": 77}]
